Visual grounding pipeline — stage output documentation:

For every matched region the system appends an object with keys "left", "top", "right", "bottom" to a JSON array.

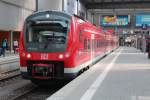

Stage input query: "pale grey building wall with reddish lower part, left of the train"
[{"left": 0, "top": 0, "right": 36, "bottom": 50}]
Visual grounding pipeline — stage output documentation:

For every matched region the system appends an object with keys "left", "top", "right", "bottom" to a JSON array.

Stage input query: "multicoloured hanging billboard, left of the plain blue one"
[{"left": 100, "top": 15, "right": 130, "bottom": 26}]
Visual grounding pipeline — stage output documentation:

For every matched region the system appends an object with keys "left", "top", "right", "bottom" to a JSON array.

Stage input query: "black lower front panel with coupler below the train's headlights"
[{"left": 27, "top": 61, "right": 64, "bottom": 78}]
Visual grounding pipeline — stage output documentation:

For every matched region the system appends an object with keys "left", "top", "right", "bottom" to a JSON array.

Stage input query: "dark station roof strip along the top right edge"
[{"left": 80, "top": 0, "right": 150, "bottom": 9}]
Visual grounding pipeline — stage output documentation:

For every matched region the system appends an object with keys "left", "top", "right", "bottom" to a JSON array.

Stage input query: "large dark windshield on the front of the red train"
[{"left": 25, "top": 18, "right": 70, "bottom": 52}]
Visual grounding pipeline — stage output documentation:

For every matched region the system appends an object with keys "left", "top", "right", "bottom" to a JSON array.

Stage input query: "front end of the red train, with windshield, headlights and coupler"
[{"left": 20, "top": 11, "right": 71, "bottom": 80}]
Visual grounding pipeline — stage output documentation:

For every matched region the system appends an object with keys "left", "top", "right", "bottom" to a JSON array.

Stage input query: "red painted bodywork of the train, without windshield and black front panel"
[{"left": 19, "top": 11, "right": 118, "bottom": 79}]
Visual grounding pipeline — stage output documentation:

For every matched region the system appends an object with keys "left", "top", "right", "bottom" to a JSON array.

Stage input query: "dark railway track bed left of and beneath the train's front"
[{"left": 0, "top": 69, "right": 66, "bottom": 100}]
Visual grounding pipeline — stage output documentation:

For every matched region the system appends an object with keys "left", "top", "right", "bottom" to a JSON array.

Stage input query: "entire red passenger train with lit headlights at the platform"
[{"left": 19, "top": 11, "right": 118, "bottom": 82}]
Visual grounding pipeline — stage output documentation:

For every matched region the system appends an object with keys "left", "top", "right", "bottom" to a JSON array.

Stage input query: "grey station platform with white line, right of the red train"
[{"left": 46, "top": 47, "right": 150, "bottom": 100}]
